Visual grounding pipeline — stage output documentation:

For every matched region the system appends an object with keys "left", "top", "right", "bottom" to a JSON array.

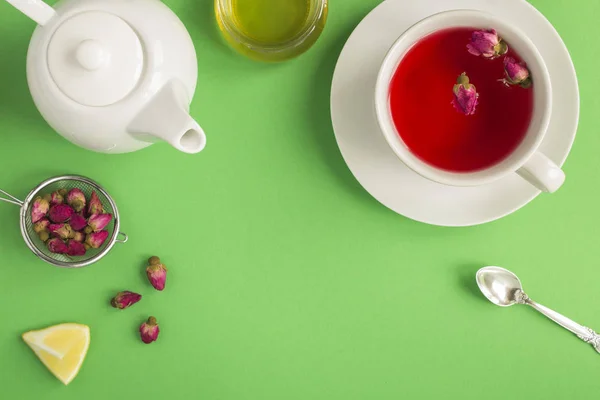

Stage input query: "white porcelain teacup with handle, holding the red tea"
[{"left": 375, "top": 10, "right": 565, "bottom": 193}]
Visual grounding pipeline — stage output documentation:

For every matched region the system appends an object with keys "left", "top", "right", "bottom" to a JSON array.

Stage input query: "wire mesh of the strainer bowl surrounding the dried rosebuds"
[{"left": 21, "top": 179, "right": 118, "bottom": 263}]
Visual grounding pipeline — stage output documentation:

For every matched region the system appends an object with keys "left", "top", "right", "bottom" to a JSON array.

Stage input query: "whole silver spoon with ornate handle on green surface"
[{"left": 476, "top": 267, "right": 600, "bottom": 353}]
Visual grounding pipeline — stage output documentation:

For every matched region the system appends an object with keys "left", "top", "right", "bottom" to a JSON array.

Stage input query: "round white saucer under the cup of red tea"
[{"left": 331, "top": 0, "right": 579, "bottom": 226}]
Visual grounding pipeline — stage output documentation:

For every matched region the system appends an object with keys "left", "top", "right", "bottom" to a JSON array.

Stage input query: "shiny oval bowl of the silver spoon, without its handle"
[{"left": 476, "top": 267, "right": 523, "bottom": 307}]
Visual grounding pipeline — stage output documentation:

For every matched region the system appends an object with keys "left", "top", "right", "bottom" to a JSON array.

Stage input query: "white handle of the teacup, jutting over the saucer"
[{"left": 517, "top": 151, "right": 565, "bottom": 193}]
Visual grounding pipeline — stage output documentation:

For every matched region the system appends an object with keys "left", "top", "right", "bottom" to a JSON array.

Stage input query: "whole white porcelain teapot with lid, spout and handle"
[{"left": 7, "top": 0, "right": 206, "bottom": 153}]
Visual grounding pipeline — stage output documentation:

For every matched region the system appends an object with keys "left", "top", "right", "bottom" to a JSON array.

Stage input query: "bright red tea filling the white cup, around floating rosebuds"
[{"left": 389, "top": 28, "right": 535, "bottom": 172}]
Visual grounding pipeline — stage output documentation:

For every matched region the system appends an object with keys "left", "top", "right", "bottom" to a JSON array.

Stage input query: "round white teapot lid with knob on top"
[{"left": 47, "top": 11, "right": 144, "bottom": 107}]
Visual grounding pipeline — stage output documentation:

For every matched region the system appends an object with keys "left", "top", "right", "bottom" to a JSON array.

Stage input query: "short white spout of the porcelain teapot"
[{"left": 128, "top": 80, "right": 206, "bottom": 154}]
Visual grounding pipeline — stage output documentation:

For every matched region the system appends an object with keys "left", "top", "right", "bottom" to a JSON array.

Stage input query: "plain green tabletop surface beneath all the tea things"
[{"left": 0, "top": 0, "right": 600, "bottom": 400}]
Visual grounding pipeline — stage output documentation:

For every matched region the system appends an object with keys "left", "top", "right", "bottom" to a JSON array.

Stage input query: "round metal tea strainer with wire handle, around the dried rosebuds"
[{"left": 0, "top": 175, "right": 128, "bottom": 268}]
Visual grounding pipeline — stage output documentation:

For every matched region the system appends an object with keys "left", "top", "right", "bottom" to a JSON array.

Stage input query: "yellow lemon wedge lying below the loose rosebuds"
[{"left": 22, "top": 324, "right": 90, "bottom": 385}]
